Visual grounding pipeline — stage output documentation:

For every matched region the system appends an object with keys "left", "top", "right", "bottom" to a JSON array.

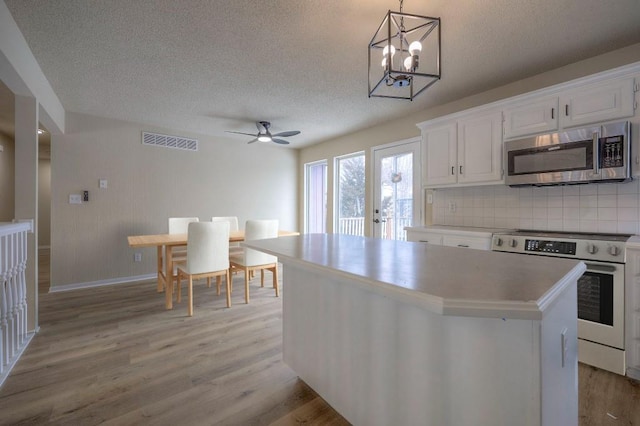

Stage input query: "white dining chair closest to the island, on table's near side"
[{"left": 229, "top": 220, "right": 280, "bottom": 303}]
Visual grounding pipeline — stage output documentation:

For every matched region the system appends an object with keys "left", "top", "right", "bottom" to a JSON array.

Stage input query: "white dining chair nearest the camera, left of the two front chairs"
[{"left": 177, "top": 222, "right": 231, "bottom": 316}]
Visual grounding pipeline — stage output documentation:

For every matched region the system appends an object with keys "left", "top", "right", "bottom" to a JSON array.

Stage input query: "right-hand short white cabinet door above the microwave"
[{"left": 560, "top": 78, "right": 634, "bottom": 127}]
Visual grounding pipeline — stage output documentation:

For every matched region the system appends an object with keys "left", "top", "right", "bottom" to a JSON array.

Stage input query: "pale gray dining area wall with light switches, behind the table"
[{"left": 51, "top": 113, "right": 298, "bottom": 288}]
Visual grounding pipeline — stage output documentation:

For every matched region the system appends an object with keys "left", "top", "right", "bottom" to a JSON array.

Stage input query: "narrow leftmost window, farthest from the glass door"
[{"left": 304, "top": 160, "right": 327, "bottom": 233}]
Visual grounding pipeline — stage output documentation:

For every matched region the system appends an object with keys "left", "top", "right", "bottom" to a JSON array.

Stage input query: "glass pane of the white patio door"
[{"left": 380, "top": 152, "right": 413, "bottom": 240}]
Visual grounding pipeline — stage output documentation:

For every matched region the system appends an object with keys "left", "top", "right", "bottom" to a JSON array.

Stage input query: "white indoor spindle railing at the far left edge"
[{"left": 0, "top": 223, "right": 31, "bottom": 385}]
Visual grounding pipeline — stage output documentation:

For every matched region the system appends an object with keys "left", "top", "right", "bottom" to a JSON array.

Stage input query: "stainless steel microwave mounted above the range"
[{"left": 504, "top": 121, "right": 632, "bottom": 186}]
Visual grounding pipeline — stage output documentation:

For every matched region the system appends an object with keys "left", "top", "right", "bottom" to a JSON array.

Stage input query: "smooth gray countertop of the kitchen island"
[{"left": 243, "top": 234, "right": 585, "bottom": 319}]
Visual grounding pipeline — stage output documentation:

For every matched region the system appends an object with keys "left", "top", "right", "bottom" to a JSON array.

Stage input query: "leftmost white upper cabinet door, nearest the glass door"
[{"left": 422, "top": 120, "right": 458, "bottom": 185}]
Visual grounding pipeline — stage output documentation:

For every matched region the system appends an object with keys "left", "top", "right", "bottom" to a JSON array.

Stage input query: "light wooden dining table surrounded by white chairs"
[{"left": 127, "top": 230, "right": 299, "bottom": 309}]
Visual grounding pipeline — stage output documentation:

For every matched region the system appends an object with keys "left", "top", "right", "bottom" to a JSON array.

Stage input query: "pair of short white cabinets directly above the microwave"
[{"left": 504, "top": 78, "right": 634, "bottom": 139}]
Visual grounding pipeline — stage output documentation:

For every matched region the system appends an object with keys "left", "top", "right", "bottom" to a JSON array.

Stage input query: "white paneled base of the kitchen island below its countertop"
[{"left": 247, "top": 236, "right": 582, "bottom": 426}]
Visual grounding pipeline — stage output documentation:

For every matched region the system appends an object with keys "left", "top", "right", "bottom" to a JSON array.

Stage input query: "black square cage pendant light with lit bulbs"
[{"left": 369, "top": 0, "right": 440, "bottom": 100}]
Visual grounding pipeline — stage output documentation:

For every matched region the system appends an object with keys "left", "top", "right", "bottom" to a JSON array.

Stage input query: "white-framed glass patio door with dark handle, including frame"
[{"left": 373, "top": 138, "right": 422, "bottom": 241}]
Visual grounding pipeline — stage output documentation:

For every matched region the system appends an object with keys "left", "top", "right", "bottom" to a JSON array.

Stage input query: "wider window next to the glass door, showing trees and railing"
[{"left": 335, "top": 153, "right": 365, "bottom": 236}]
